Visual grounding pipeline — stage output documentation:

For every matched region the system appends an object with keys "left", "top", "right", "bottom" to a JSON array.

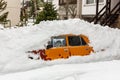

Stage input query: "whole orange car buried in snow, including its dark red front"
[{"left": 28, "top": 34, "right": 94, "bottom": 60}]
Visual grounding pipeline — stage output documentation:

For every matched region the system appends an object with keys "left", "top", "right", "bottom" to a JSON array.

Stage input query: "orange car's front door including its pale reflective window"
[{"left": 46, "top": 37, "right": 69, "bottom": 59}]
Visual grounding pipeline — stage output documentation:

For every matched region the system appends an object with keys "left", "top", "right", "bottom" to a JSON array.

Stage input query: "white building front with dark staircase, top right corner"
[{"left": 82, "top": 0, "right": 120, "bottom": 28}]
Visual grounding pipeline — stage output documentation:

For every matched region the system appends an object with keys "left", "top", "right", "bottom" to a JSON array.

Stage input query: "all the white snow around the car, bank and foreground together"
[{"left": 0, "top": 19, "right": 120, "bottom": 80}]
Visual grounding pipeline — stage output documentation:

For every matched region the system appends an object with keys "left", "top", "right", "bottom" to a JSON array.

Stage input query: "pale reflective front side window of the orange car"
[{"left": 52, "top": 37, "right": 66, "bottom": 47}]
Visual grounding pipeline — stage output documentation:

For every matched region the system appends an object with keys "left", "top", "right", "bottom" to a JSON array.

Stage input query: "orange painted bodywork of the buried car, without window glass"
[{"left": 45, "top": 34, "right": 94, "bottom": 60}]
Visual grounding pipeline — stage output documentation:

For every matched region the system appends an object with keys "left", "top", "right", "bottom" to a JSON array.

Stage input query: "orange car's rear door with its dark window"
[{"left": 68, "top": 36, "right": 89, "bottom": 56}]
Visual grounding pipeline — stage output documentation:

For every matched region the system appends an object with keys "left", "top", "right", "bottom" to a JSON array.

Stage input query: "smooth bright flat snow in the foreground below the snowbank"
[{"left": 0, "top": 61, "right": 120, "bottom": 80}]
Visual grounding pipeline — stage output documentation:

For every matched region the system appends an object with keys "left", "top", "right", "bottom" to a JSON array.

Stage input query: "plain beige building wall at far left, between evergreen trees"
[{"left": 4, "top": 0, "right": 21, "bottom": 26}]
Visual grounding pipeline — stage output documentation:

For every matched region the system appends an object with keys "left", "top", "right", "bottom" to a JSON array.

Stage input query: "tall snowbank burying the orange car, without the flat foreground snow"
[{"left": 0, "top": 19, "right": 120, "bottom": 74}]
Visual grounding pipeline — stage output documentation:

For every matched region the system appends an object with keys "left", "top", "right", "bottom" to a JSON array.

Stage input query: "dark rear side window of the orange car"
[{"left": 68, "top": 36, "right": 86, "bottom": 46}]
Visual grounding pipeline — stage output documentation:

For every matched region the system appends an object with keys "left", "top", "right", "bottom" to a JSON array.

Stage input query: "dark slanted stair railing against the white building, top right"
[{"left": 91, "top": 1, "right": 120, "bottom": 26}]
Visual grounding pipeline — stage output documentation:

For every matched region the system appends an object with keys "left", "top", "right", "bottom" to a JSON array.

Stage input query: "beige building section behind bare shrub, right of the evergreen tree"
[{"left": 58, "top": 0, "right": 77, "bottom": 19}]
